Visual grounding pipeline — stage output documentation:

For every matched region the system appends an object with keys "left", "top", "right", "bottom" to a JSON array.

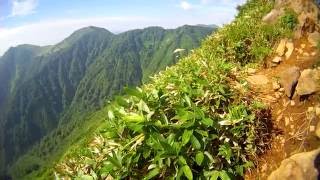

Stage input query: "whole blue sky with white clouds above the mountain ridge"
[{"left": 0, "top": 0, "right": 245, "bottom": 55}]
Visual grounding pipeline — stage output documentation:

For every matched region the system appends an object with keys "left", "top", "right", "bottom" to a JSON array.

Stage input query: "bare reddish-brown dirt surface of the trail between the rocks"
[{"left": 245, "top": 38, "right": 320, "bottom": 179}]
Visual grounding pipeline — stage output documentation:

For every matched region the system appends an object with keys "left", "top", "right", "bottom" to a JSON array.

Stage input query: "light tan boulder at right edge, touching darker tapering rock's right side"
[{"left": 296, "top": 69, "right": 320, "bottom": 96}]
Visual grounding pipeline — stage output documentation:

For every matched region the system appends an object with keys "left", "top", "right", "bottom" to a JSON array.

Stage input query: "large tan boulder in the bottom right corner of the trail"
[{"left": 268, "top": 148, "right": 320, "bottom": 180}]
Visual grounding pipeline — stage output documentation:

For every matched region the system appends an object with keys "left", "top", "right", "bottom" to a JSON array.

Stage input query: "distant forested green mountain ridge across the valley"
[{"left": 0, "top": 26, "right": 213, "bottom": 178}]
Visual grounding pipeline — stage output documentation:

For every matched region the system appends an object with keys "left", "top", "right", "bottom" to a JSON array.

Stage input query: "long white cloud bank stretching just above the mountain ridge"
[{"left": 0, "top": 16, "right": 183, "bottom": 56}]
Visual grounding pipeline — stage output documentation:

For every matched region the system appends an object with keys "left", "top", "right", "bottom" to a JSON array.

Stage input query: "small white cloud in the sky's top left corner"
[{"left": 10, "top": 0, "right": 38, "bottom": 17}]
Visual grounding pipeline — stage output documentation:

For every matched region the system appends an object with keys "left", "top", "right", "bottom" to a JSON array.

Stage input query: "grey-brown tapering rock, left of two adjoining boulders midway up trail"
[{"left": 280, "top": 66, "right": 300, "bottom": 98}]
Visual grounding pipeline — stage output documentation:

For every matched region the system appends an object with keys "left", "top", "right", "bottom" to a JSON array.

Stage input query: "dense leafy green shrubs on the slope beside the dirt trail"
[{"left": 55, "top": 0, "right": 293, "bottom": 180}]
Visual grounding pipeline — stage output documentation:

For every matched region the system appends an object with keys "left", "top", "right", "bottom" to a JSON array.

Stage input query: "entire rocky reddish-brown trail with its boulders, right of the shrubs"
[{"left": 246, "top": 1, "right": 320, "bottom": 180}]
